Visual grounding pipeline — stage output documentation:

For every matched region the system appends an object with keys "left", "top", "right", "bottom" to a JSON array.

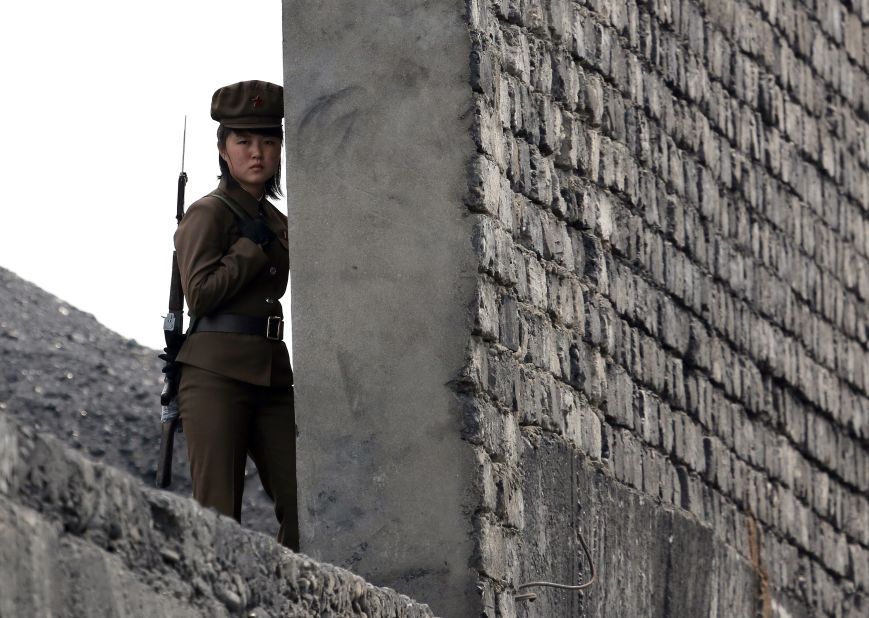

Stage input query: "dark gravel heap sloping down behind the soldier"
[{"left": 0, "top": 268, "right": 277, "bottom": 534}]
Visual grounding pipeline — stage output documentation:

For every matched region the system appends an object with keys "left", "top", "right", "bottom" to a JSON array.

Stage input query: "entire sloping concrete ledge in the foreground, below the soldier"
[{"left": 0, "top": 414, "right": 433, "bottom": 618}]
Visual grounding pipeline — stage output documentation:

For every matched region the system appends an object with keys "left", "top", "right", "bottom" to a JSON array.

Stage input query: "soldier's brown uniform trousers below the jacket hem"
[{"left": 178, "top": 365, "right": 299, "bottom": 551}]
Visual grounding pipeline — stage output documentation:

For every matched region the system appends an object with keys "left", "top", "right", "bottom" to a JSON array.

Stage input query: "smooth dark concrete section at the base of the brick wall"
[{"left": 517, "top": 435, "right": 760, "bottom": 617}]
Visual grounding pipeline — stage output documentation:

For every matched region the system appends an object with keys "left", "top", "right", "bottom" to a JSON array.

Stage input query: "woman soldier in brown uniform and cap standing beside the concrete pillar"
[{"left": 175, "top": 81, "right": 299, "bottom": 550}]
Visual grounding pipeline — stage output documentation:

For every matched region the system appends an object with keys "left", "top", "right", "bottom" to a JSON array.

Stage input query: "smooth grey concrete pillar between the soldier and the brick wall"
[{"left": 283, "top": 0, "right": 480, "bottom": 616}]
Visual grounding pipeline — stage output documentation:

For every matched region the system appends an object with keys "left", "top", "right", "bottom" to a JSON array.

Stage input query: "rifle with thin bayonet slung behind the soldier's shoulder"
[{"left": 156, "top": 116, "right": 187, "bottom": 488}]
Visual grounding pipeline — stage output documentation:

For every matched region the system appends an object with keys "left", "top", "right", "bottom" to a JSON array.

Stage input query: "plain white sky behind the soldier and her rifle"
[{"left": 0, "top": 0, "right": 289, "bottom": 348}]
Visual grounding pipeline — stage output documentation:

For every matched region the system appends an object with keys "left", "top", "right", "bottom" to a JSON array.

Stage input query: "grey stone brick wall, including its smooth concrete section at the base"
[{"left": 459, "top": 0, "right": 869, "bottom": 617}]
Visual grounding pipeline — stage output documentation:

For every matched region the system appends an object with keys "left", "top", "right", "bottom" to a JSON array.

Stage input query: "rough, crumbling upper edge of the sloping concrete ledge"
[{"left": 0, "top": 414, "right": 433, "bottom": 618}]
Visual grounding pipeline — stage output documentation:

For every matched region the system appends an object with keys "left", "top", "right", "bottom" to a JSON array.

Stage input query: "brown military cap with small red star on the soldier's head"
[{"left": 211, "top": 79, "right": 284, "bottom": 129}]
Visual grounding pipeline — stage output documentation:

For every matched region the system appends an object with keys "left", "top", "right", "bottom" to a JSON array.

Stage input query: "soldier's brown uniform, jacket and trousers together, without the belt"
[{"left": 175, "top": 182, "right": 298, "bottom": 549}]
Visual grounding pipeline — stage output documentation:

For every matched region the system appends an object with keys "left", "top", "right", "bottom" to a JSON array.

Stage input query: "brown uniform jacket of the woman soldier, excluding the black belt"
[{"left": 175, "top": 180, "right": 292, "bottom": 386}]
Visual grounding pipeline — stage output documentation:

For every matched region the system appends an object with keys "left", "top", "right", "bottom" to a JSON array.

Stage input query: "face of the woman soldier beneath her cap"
[{"left": 220, "top": 131, "right": 281, "bottom": 197}]
